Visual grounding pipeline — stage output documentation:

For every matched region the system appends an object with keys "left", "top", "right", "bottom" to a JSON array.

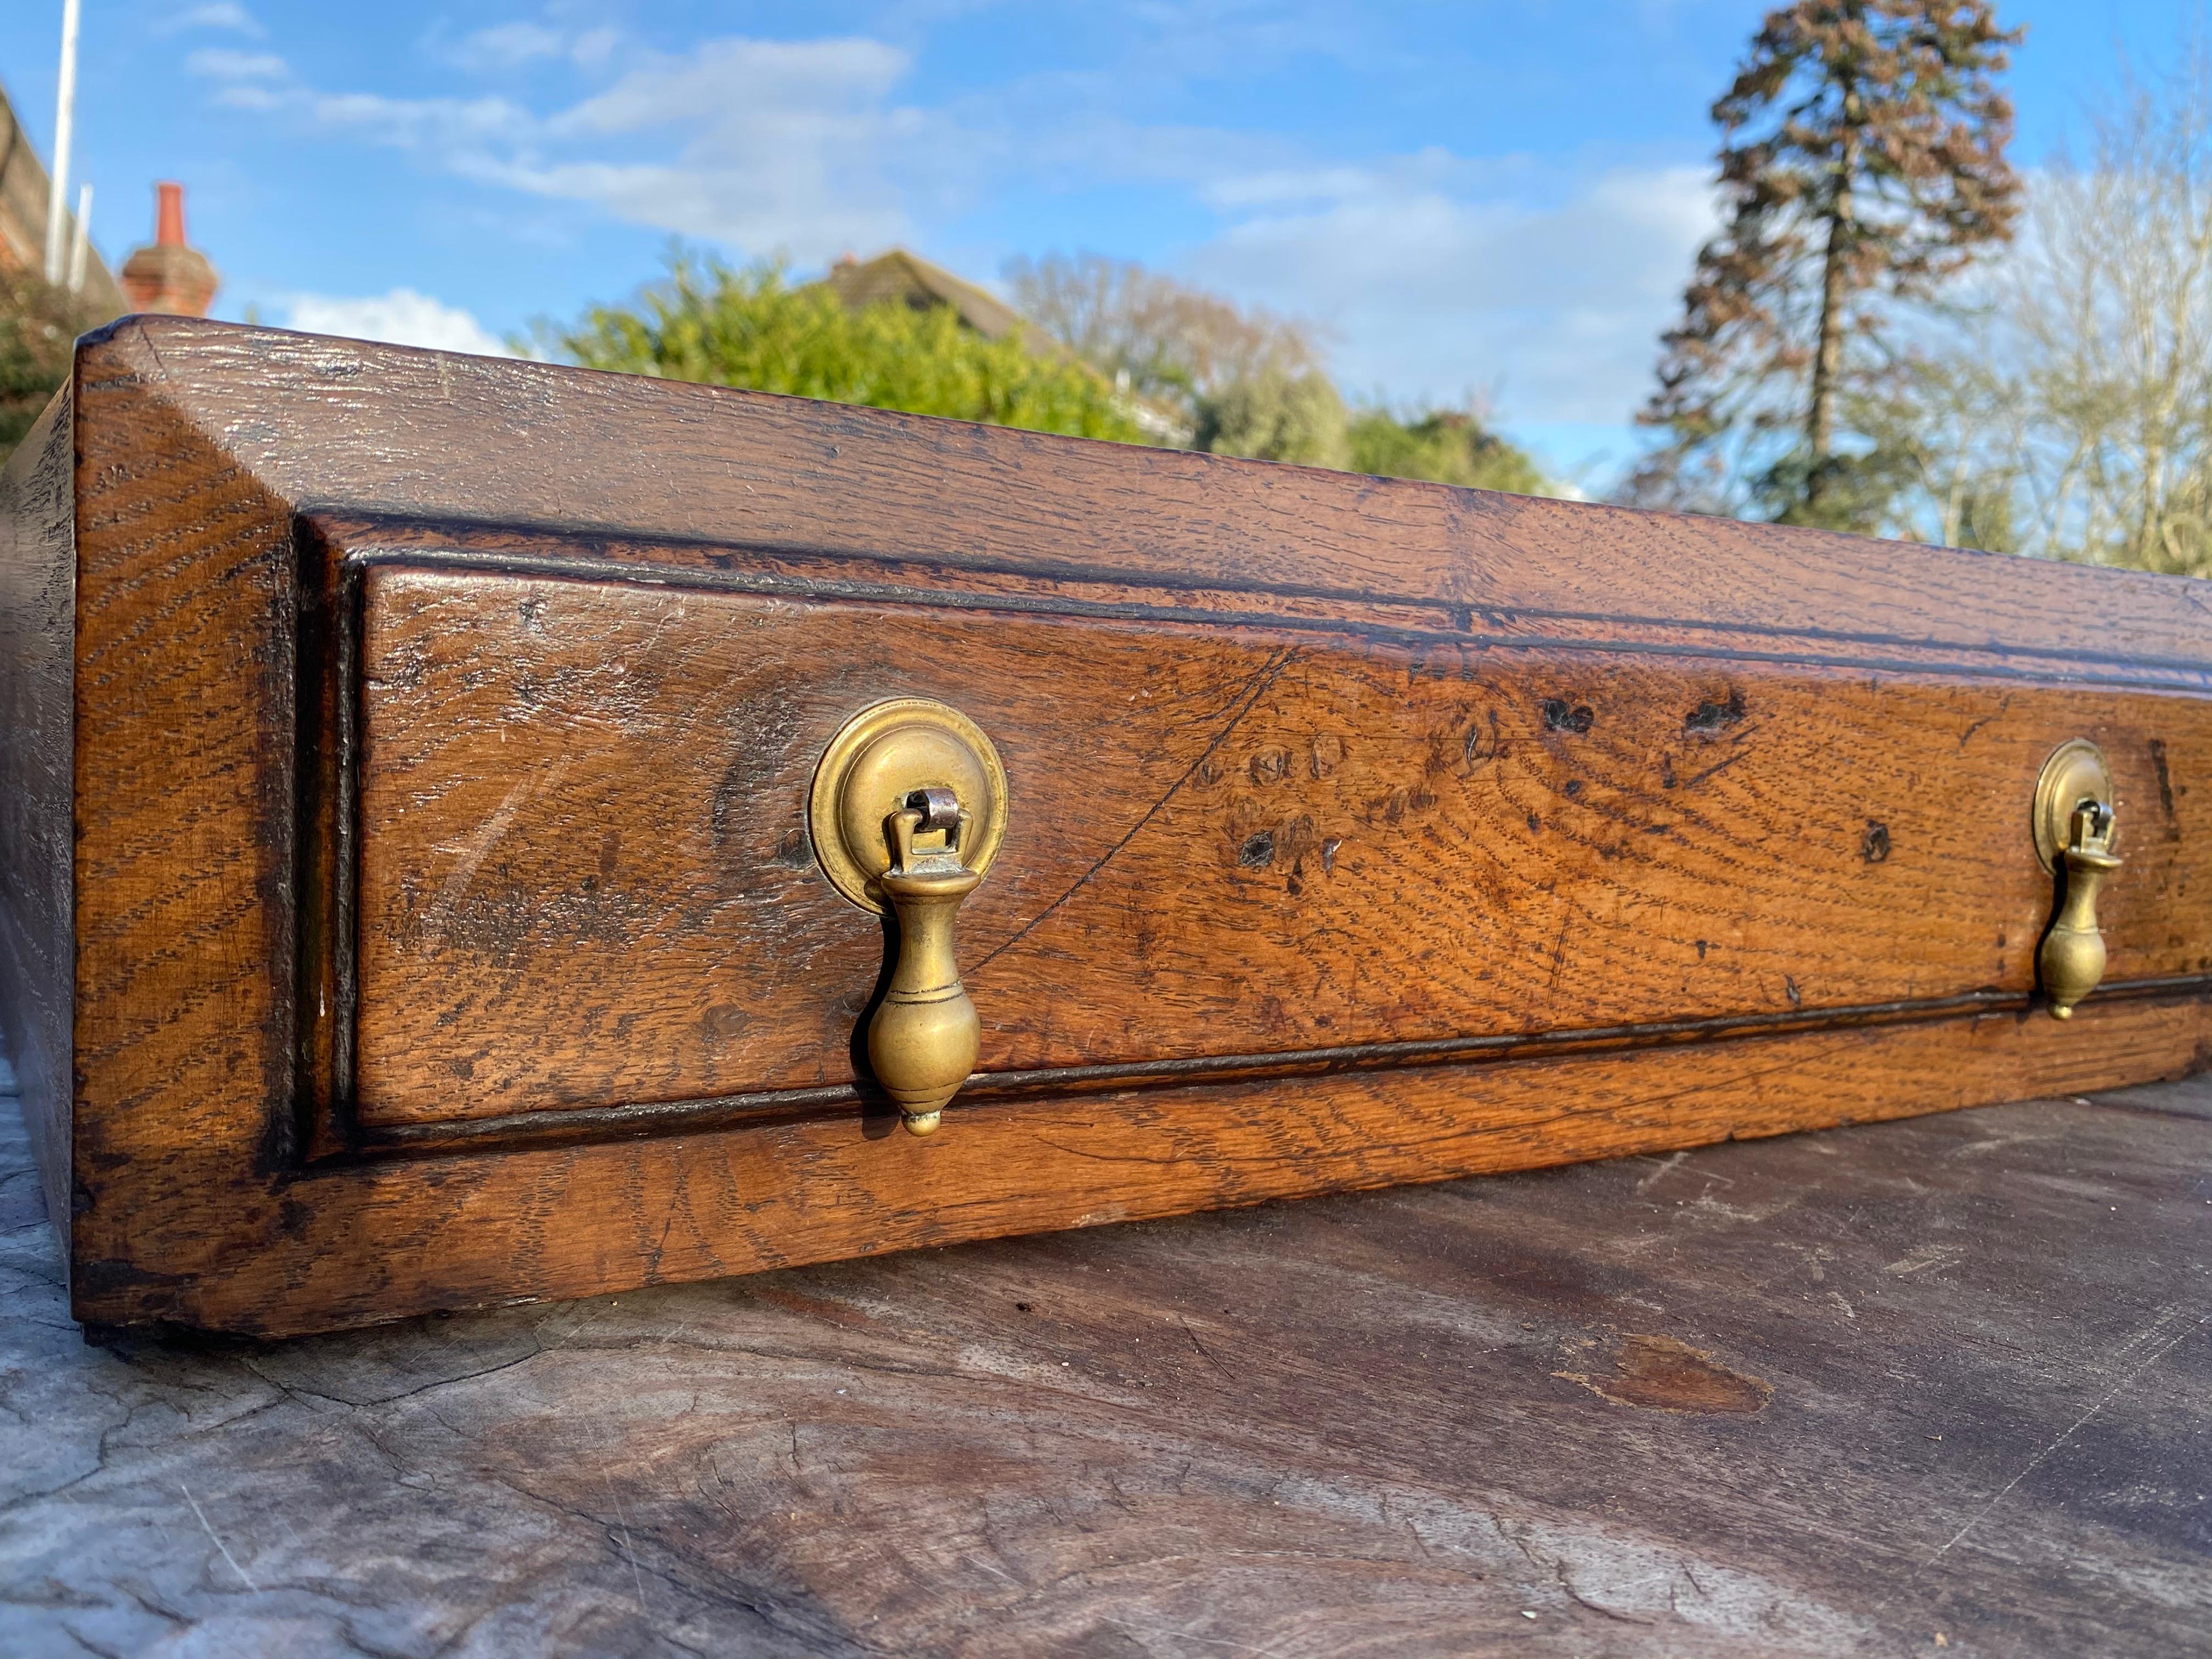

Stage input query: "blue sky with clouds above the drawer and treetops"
[{"left": 0, "top": 0, "right": 2201, "bottom": 482}]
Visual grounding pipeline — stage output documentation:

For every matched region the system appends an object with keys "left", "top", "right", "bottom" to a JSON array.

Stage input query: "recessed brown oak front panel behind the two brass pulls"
[{"left": 354, "top": 568, "right": 2212, "bottom": 1126}]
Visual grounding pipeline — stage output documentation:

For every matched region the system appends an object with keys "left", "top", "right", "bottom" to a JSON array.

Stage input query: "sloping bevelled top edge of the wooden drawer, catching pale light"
[{"left": 121, "top": 319, "right": 2212, "bottom": 677}]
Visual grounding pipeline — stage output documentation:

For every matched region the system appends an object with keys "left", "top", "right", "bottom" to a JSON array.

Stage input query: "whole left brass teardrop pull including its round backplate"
[{"left": 808, "top": 697, "right": 1007, "bottom": 1135}]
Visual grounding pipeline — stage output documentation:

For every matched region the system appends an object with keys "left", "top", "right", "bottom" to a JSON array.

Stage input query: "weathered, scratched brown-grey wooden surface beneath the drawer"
[{"left": 0, "top": 1044, "right": 2212, "bottom": 1659}]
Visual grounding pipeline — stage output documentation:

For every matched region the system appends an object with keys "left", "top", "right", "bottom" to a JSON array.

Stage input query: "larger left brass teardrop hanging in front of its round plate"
[{"left": 867, "top": 787, "right": 982, "bottom": 1135}]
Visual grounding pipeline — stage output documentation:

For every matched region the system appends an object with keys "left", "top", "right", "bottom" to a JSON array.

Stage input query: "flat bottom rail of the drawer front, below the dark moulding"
[{"left": 77, "top": 997, "right": 2212, "bottom": 1336}]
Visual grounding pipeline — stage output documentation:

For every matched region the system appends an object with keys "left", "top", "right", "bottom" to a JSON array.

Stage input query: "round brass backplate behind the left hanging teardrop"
[{"left": 808, "top": 697, "right": 1007, "bottom": 916}]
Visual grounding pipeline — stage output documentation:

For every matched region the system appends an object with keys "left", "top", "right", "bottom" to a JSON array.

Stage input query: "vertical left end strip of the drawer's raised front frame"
[{"left": 71, "top": 328, "right": 298, "bottom": 1321}]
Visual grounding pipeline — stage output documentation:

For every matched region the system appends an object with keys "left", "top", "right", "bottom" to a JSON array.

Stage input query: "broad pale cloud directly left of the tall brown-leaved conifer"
[{"left": 1186, "top": 153, "right": 1714, "bottom": 422}]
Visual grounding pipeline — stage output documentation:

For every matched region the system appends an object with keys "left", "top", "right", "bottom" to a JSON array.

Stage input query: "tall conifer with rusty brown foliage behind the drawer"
[{"left": 1628, "top": 0, "right": 2022, "bottom": 529}]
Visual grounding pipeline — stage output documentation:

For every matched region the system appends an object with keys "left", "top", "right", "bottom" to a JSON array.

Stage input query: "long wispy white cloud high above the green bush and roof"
[{"left": 206, "top": 22, "right": 1294, "bottom": 266}]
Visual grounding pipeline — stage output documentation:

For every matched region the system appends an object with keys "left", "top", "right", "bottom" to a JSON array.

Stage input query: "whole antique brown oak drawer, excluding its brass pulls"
[{"left": 0, "top": 319, "right": 2212, "bottom": 1331}]
